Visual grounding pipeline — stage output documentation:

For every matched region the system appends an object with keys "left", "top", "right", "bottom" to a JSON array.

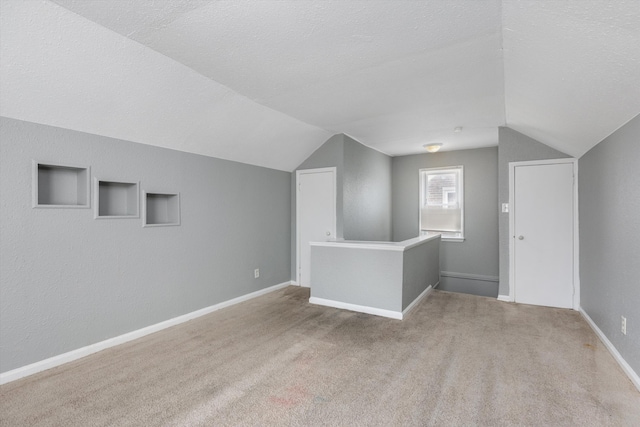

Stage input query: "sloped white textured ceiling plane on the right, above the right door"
[{"left": 503, "top": 0, "right": 640, "bottom": 157}]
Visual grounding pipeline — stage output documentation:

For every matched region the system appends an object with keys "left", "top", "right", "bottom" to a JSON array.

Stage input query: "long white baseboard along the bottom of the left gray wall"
[{"left": 0, "top": 282, "right": 291, "bottom": 384}]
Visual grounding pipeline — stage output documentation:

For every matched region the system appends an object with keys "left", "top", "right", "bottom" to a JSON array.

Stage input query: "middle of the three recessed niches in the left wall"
[{"left": 94, "top": 178, "right": 140, "bottom": 219}]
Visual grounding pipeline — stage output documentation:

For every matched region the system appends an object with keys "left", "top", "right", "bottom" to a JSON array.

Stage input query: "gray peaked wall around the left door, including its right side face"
[{"left": 291, "top": 134, "right": 392, "bottom": 280}]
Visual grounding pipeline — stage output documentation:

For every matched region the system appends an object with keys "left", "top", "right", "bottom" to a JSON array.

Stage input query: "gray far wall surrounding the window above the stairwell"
[{"left": 392, "top": 147, "right": 498, "bottom": 296}]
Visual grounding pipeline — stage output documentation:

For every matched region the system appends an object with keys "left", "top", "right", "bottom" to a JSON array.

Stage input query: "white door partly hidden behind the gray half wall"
[{"left": 296, "top": 168, "right": 336, "bottom": 287}]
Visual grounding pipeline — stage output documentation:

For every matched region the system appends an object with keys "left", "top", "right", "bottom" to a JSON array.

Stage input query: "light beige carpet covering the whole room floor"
[{"left": 0, "top": 287, "right": 640, "bottom": 426}]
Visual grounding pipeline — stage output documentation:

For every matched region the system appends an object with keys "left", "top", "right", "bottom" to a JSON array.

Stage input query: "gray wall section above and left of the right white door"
[{"left": 496, "top": 127, "right": 571, "bottom": 295}]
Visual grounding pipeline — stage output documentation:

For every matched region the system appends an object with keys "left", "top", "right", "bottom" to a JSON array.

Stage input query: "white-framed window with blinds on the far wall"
[{"left": 420, "top": 166, "right": 464, "bottom": 241}]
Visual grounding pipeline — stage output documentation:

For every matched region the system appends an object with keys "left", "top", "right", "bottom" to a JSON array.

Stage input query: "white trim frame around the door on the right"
[{"left": 509, "top": 157, "right": 580, "bottom": 310}]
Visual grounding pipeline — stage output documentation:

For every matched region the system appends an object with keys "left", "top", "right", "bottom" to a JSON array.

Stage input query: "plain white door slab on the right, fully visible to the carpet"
[{"left": 511, "top": 162, "right": 575, "bottom": 308}]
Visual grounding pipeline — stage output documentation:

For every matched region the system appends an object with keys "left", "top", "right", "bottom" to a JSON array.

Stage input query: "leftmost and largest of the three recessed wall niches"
[{"left": 32, "top": 160, "right": 91, "bottom": 208}]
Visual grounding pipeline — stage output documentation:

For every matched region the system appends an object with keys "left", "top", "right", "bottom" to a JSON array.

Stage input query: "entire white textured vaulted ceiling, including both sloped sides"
[{"left": 0, "top": 0, "right": 640, "bottom": 171}]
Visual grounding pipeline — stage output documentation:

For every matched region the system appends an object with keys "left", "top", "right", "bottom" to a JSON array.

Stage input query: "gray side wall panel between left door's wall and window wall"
[{"left": 343, "top": 136, "right": 392, "bottom": 241}]
